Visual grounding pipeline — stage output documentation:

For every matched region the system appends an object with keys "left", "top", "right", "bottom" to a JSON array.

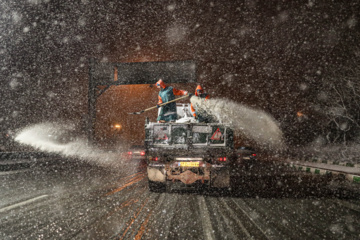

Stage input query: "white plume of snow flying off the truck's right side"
[{"left": 190, "top": 97, "right": 283, "bottom": 150}]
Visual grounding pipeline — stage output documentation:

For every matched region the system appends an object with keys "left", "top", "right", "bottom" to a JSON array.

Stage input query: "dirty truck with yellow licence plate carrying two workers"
[{"left": 145, "top": 103, "right": 237, "bottom": 192}]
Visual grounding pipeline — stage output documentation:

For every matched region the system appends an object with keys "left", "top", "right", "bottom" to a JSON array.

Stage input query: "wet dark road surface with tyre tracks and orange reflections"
[{"left": 0, "top": 160, "right": 360, "bottom": 239}]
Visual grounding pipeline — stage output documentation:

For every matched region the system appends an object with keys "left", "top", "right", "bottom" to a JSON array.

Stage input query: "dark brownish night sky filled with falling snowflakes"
[{"left": 0, "top": 0, "right": 360, "bottom": 147}]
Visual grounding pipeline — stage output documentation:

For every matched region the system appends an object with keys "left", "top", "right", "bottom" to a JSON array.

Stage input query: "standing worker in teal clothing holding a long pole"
[{"left": 156, "top": 79, "right": 188, "bottom": 122}]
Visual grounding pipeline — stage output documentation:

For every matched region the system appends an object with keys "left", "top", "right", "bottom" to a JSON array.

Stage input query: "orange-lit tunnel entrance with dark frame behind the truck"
[{"left": 87, "top": 59, "right": 197, "bottom": 147}]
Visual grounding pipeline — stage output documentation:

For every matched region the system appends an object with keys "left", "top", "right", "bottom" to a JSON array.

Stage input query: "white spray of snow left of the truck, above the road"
[{"left": 15, "top": 123, "right": 125, "bottom": 166}]
